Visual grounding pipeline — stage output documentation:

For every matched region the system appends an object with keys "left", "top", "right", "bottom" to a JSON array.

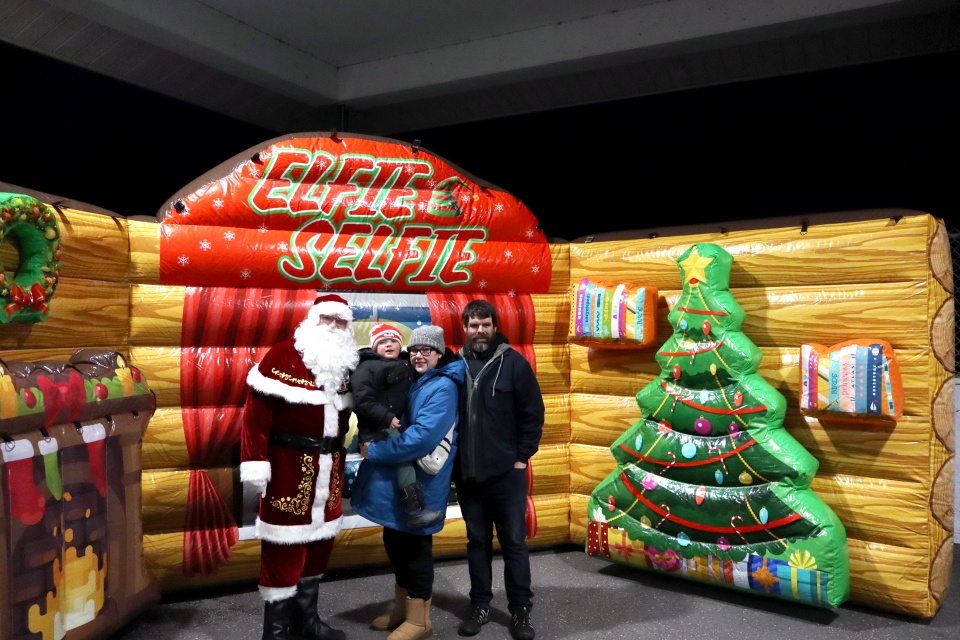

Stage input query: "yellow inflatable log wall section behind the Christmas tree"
[{"left": 570, "top": 215, "right": 954, "bottom": 616}]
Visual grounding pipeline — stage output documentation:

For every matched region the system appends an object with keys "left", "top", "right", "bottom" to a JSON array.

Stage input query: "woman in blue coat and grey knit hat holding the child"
[{"left": 350, "top": 326, "right": 465, "bottom": 640}]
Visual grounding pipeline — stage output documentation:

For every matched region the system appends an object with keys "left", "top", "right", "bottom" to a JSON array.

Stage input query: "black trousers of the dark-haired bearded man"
[{"left": 457, "top": 469, "right": 533, "bottom": 613}]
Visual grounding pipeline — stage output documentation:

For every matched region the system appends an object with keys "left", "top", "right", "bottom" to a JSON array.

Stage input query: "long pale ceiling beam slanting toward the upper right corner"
[{"left": 339, "top": 0, "right": 951, "bottom": 108}]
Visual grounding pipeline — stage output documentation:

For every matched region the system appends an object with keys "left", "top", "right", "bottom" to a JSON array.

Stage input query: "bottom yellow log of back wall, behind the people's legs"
[{"left": 143, "top": 494, "right": 570, "bottom": 592}]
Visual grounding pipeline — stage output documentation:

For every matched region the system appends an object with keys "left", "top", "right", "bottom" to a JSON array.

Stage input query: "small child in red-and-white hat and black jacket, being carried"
[{"left": 350, "top": 322, "right": 441, "bottom": 529}]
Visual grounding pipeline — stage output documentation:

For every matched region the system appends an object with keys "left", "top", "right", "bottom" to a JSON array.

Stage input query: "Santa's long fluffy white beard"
[{"left": 293, "top": 318, "right": 359, "bottom": 393}]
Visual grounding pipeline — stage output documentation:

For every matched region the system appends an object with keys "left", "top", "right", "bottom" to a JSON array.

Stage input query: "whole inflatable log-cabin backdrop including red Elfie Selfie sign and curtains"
[{"left": 0, "top": 134, "right": 954, "bottom": 616}]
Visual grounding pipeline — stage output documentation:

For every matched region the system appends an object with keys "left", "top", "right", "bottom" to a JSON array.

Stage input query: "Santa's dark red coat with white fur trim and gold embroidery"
[{"left": 240, "top": 340, "right": 353, "bottom": 544}]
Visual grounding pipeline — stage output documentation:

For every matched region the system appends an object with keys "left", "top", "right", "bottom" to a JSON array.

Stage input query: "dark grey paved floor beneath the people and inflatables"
[{"left": 113, "top": 546, "right": 960, "bottom": 640}]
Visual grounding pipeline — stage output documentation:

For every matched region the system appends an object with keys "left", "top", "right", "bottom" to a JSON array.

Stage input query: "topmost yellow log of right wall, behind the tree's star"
[{"left": 570, "top": 215, "right": 935, "bottom": 290}]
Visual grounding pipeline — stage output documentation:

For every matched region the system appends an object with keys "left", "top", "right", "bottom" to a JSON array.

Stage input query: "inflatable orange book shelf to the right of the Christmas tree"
[{"left": 800, "top": 338, "right": 903, "bottom": 422}]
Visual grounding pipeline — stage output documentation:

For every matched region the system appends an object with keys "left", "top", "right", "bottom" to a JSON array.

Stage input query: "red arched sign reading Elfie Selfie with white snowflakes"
[{"left": 159, "top": 134, "right": 551, "bottom": 293}]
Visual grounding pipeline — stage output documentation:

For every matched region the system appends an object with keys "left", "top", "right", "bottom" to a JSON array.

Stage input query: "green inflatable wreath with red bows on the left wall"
[{"left": 0, "top": 193, "right": 61, "bottom": 324}]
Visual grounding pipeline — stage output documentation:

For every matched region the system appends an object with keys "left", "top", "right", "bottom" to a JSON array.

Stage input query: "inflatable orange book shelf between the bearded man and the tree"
[{"left": 568, "top": 278, "right": 657, "bottom": 349}]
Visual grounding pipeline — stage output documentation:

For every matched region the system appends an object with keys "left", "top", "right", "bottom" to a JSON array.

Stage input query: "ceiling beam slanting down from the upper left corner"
[{"left": 46, "top": 0, "right": 337, "bottom": 107}]
